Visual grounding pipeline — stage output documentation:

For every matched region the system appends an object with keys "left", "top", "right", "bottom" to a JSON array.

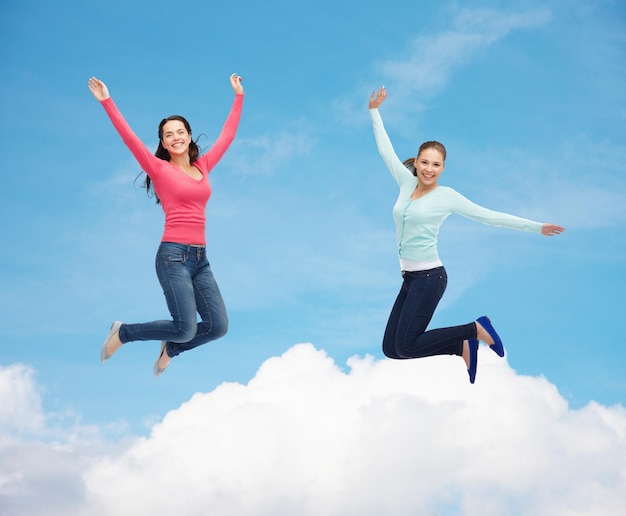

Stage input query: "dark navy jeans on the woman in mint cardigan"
[{"left": 383, "top": 267, "right": 476, "bottom": 359}]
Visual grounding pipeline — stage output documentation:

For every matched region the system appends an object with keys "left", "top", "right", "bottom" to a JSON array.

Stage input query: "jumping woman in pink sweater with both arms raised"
[{"left": 88, "top": 74, "right": 244, "bottom": 376}]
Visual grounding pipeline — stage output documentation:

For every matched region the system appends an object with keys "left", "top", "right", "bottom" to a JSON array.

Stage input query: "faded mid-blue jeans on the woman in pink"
[{"left": 119, "top": 242, "right": 228, "bottom": 357}]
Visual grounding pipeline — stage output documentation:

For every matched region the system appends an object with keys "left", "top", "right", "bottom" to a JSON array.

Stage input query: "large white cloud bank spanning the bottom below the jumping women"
[{"left": 0, "top": 344, "right": 626, "bottom": 516}]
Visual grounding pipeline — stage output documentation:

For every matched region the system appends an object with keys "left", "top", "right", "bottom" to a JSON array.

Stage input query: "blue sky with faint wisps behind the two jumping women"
[{"left": 0, "top": 0, "right": 626, "bottom": 513}]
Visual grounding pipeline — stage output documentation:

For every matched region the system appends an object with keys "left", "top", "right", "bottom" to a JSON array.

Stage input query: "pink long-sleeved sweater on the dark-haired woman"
[{"left": 102, "top": 94, "right": 243, "bottom": 245}]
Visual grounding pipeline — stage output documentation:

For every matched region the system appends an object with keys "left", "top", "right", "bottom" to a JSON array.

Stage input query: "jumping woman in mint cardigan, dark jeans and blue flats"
[{"left": 369, "top": 86, "right": 564, "bottom": 383}]
